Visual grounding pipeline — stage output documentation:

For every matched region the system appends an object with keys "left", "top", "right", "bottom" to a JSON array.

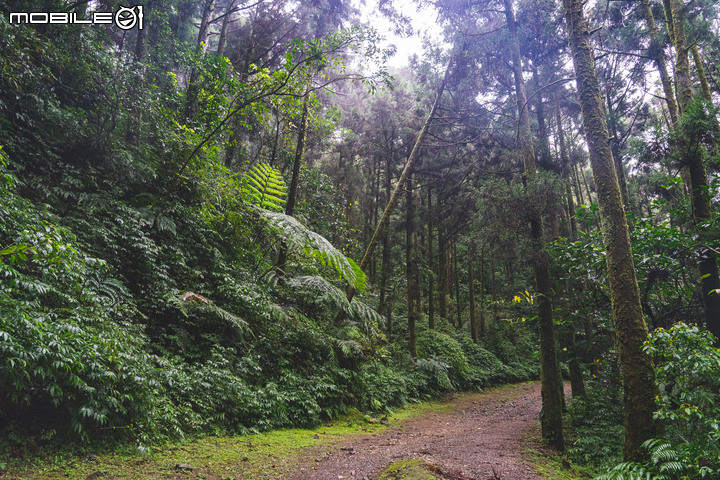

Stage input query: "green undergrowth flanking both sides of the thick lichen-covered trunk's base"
[{"left": 569, "top": 323, "right": 720, "bottom": 480}]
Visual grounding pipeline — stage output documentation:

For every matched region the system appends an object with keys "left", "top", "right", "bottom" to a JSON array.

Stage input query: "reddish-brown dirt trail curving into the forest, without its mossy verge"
[{"left": 291, "top": 382, "right": 556, "bottom": 480}]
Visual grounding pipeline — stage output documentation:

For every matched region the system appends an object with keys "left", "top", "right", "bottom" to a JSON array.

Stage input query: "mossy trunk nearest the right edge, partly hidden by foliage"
[{"left": 670, "top": 0, "right": 720, "bottom": 337}]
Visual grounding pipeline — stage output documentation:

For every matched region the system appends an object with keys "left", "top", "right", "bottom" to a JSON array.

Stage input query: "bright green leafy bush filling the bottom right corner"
[{"left": 599, "top": 323, "right": 720, "bottom": 480}]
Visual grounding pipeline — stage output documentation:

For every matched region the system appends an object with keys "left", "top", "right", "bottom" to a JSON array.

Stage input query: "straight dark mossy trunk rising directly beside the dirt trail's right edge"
[{"left": 504, "top": 0, "right": 565, "bottom": 450}]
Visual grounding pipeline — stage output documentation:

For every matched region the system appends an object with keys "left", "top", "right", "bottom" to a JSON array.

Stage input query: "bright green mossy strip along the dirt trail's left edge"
[{"left": 0, "top": 394, "right": 465, "bottom": 480}]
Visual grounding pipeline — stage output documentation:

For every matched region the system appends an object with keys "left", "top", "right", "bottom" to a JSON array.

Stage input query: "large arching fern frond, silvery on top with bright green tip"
[{"left": 257, "top": 209, "right": 366, "bottom": 293}]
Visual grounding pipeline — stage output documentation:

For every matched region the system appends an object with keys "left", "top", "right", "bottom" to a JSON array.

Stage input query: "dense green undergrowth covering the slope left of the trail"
[{"left": 0, "top": 138, "right": 537, "bottom": 455}]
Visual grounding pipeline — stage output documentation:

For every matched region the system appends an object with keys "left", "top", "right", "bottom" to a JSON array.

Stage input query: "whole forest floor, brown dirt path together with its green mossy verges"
[{"left": 0, "top": 382, "right": 589, "bottom": 480}]
